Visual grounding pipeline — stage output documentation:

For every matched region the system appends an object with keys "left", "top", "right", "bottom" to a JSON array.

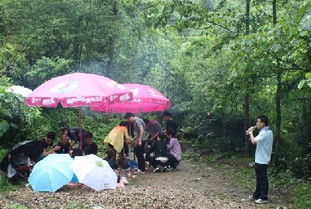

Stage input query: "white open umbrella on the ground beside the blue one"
[{"left": 71, "top": 155, "right": 118, "bottom": 191}]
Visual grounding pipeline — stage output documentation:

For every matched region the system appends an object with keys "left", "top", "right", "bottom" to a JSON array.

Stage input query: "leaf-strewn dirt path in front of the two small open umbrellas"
[{"left": 0, "top": 161, "right": 292, "bottom": 209}]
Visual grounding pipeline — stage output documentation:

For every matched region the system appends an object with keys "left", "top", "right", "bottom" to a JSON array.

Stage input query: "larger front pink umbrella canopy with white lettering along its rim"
[{"left": 26, "top": 73, "right": 133, "bottom": 107}]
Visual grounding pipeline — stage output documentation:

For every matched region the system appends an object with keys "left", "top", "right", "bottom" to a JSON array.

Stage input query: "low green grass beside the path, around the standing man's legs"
[{"left": 183, "top": 153, "right": 311, "bottom": 209}]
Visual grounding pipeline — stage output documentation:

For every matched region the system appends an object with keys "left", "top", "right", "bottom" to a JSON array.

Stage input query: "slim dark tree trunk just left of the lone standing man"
[{"left": 243, "top": 0, "right": 250, "bottom": 155}]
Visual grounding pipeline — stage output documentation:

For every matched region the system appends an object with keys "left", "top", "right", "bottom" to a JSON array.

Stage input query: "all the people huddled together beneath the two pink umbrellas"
[{"left": 0, "top": 111, "right": 181, "bottom": 180}]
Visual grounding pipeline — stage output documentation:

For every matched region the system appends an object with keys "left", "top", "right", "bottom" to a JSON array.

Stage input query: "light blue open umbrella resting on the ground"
[{"left": 28, "top": 154, "right": 73, "bottom": 192}]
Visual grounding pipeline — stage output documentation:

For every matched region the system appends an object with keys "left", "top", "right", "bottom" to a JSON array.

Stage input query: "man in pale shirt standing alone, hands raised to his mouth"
[{"left": 247, "top": 115, "right": 273, "bottom": 204}]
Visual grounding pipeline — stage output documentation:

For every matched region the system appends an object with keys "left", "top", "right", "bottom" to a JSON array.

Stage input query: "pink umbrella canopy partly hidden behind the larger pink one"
[{"left": 91, "top": 84, "right": 171, "bottom": 113}]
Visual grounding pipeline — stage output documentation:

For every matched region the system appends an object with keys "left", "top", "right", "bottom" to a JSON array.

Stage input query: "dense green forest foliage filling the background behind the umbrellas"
[{"left": 0, "top": 0, "right": 311, "bottom": 189}]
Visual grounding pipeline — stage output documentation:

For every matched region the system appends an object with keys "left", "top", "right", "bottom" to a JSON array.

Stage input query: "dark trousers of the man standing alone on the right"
[{"left": 253, "top": 163, "right": 269, "bottom": 200}]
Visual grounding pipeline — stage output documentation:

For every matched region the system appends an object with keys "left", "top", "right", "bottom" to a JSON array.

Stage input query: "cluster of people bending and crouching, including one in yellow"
[{"left": 104, "top": 111, "right": 181, "bottom": 172}]
